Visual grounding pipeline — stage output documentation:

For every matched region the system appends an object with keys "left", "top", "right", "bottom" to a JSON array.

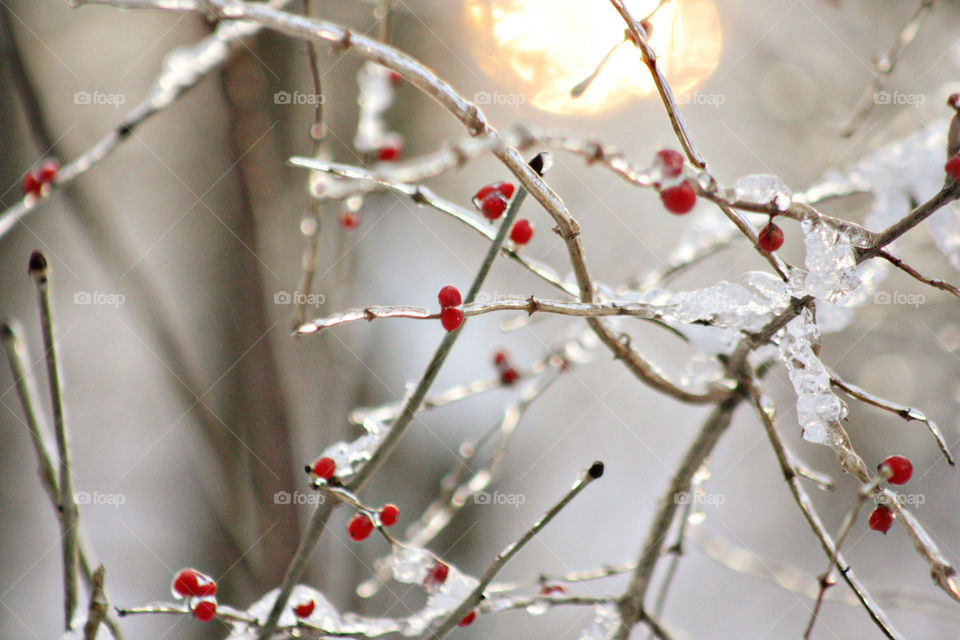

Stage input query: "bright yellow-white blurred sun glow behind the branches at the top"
[{"left": 467, "top": 0, "right": 723, "bottom": 113}]
